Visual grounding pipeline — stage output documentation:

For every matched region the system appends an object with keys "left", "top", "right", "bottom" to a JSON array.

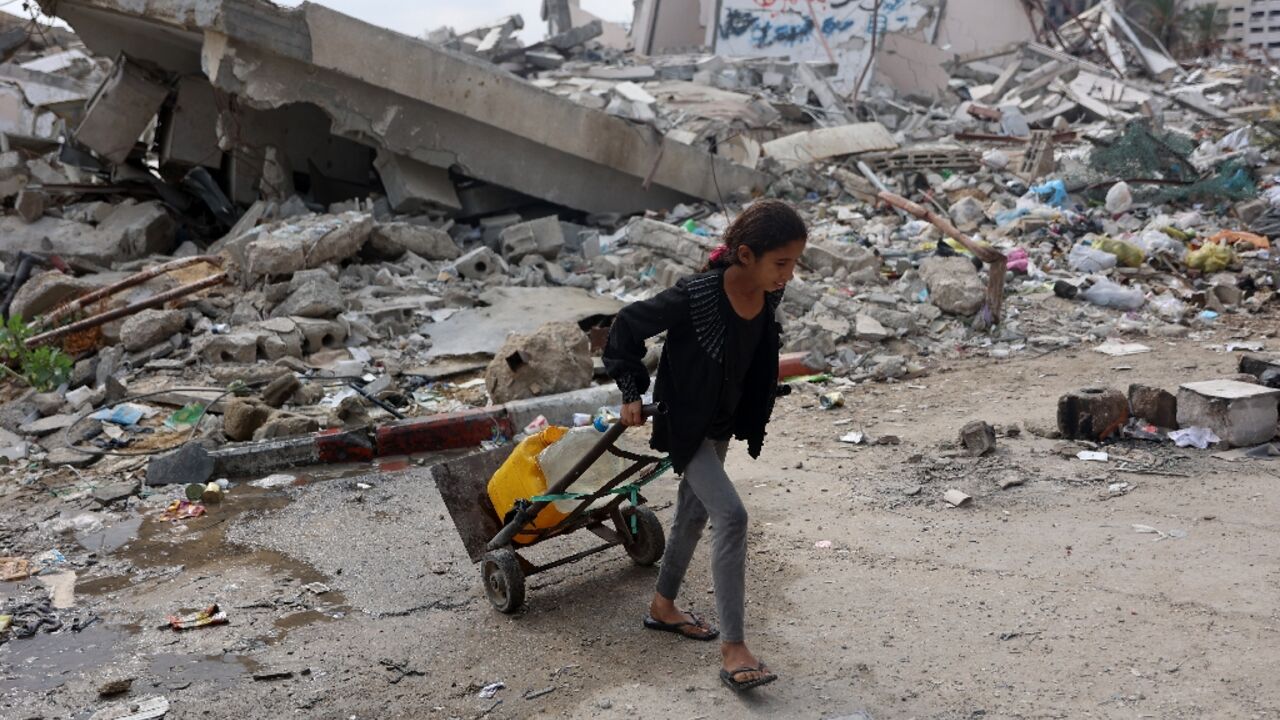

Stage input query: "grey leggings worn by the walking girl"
[{"left": 658, "top": 439, "right": 746, "bottom": 642}]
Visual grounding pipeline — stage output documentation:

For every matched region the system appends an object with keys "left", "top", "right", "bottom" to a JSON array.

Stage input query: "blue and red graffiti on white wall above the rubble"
[{"left": 716, "top": 0, "right": 929, "bottom": 90}]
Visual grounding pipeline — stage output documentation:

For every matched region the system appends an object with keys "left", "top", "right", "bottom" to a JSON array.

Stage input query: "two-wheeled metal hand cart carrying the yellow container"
[{"left": 433, "top": 405, "right": 671, "bottom": 612}]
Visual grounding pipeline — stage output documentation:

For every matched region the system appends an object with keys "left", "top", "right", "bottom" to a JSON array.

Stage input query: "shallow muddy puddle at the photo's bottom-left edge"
[{"left": 0, "top": 624, "right": 123, "bottom": 693}]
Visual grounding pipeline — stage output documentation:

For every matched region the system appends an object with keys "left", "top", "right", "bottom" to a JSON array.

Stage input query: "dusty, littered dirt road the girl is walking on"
[{"left": 0, "top": 298, "right": 1280, "bottom": 720}]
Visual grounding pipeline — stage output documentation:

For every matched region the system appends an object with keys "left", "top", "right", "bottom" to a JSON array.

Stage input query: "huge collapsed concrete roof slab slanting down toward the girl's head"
[{"left": 45, "top": 0, "right": 767, "bottom": 213}]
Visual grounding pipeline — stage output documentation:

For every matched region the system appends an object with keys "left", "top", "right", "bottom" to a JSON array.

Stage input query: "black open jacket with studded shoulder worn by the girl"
[{"left": 604, "top": 269, "right": 782, "bottom": 473}]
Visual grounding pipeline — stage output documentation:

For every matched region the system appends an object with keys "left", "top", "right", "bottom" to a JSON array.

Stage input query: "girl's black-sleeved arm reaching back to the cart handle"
[{"left": 604, "top": 286, "right": 689, "bottom": 405}]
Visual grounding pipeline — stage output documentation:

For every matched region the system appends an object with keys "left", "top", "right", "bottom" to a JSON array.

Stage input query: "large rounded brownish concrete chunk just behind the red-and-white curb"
[{"left": 484, "top": 323, "right": 593, "bottom": 404}]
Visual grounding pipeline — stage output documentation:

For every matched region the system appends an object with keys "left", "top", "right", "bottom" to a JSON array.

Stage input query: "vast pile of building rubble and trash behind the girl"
[{"left": 0, "top": 0, "right": 1259, "bottom": 499}]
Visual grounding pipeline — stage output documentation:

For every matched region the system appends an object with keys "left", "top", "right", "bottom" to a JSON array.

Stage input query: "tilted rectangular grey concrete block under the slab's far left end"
[{"left": 74, "top": 55, "right": 169, "bottom": 165}]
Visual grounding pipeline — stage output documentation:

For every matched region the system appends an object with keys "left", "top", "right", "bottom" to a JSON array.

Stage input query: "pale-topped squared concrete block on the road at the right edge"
[{"left": 1178, "top": 380, "right": 1280, "bottom": 447}]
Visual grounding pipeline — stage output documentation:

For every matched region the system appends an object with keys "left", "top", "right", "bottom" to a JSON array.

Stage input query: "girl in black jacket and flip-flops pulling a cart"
[{"left": 604, "top": 200, "right": 809, "bottom": 692}]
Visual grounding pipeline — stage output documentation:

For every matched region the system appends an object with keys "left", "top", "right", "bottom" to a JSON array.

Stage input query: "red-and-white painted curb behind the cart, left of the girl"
[{"left": 209, "top": 384, "right": 622, "bottom": 478}]
